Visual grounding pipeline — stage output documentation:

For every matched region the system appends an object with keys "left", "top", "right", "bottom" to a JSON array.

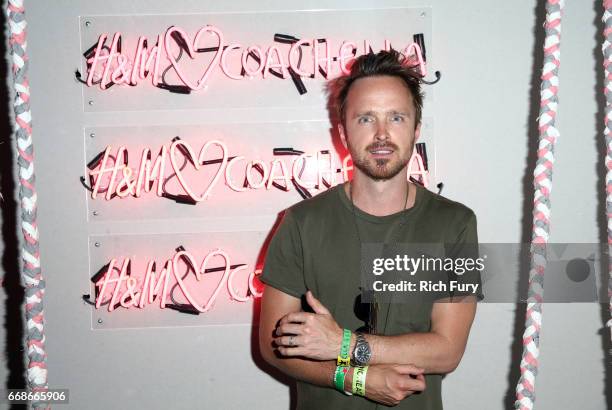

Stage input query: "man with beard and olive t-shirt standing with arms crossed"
[{"left": 259, "top": 51, "right": 477, "bottom": 410}]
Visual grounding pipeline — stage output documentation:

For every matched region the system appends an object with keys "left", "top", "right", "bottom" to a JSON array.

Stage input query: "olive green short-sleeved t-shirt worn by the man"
[{"left": 261, "top": 184, "right": 482, "bottom": 410}]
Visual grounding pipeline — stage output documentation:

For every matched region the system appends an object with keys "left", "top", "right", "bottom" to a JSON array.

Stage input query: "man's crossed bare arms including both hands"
[{"left": 259, "top": 286, "right": 476, "bottom": 405}]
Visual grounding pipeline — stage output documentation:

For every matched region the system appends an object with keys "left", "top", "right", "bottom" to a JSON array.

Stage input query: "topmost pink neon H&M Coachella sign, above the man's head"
[{"left": 85, "top": 25, "right": 427, "bottom": 91}]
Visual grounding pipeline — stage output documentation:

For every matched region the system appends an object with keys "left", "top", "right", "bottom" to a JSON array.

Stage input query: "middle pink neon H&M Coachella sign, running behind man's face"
[{"left": 88, "top": 139, "right": 429, "bottom": 202}]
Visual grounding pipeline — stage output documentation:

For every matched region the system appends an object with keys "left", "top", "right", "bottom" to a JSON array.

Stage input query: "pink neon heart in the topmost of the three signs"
[{"left": 164, "top": 25, "right": 223, "bottom": 90}]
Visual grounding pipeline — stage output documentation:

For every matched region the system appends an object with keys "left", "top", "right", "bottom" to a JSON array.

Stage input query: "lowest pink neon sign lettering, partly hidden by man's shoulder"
[{"left": 95, "top": 248, "right": 262, "bottom": 313}]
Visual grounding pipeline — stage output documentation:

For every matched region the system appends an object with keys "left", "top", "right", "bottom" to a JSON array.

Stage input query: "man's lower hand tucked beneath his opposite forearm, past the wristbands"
[{"left": 366, "top": 364, "right": 425, "bottom": 406}]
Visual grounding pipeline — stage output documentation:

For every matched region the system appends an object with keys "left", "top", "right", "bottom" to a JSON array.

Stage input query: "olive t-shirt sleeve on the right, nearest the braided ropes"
[{"left": 446, "top": 210, "right": 484, "bottom": 301}]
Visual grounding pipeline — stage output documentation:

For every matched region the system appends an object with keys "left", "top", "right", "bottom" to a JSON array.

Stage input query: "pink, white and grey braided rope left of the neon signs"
[{"left": 6, "top": 0, "right": 48, "bottom": 408}]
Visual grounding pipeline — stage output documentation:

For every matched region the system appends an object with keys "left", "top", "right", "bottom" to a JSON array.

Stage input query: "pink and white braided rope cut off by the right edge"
[{"left": 601, "top": 0, "right": 612, "bottom": 346}]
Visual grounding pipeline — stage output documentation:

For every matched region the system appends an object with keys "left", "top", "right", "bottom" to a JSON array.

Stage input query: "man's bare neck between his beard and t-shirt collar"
[{"left": 344, "top": 171, "right": 416, "bottom": 216}]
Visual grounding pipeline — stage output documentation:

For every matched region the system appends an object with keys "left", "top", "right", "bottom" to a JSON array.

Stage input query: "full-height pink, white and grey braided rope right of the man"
[{"left": 514, "top": 0, "right": 563, "bottom": 410}]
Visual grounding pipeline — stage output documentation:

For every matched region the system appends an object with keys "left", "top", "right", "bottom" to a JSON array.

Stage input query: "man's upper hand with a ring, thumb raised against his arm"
[{"left": 274, "top": 291, "right": 342, "bottom": 360}]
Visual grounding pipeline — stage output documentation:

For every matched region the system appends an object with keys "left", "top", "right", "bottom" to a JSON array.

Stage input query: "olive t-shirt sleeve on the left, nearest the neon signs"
[{"left": 260, "top": 209, "right": 306, "bottom": 298}]
